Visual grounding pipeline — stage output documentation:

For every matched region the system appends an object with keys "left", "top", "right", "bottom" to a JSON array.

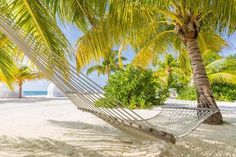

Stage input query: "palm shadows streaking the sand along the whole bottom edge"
[{"left": 0, "top": 120, "right": 236, "bottom": 157}]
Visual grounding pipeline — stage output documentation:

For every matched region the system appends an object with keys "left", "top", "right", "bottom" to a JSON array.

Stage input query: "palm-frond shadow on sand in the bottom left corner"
[{"left": 0, "top": 136, "right": 108, "bottom": 157}]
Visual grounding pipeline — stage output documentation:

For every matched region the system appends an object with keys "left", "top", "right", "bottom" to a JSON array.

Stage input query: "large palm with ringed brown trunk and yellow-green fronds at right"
[{"left": 78, "top": 0, "right": 236, "bottom": 124}]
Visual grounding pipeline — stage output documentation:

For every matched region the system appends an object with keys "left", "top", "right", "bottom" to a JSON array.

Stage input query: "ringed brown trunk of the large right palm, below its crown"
[{"left": 185, "top": 38, "right": 223, "bottom": 124}]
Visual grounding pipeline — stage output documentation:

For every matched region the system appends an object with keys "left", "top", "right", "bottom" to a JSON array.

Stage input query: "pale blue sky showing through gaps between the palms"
[{"left": 23, "top": 23, "right": 236, "bottom": 91}]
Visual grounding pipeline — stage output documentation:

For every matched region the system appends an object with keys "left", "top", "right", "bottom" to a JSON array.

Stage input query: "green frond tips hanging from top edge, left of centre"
[{"left": 46, "top": 0, "right": 107, "bottom": 33}]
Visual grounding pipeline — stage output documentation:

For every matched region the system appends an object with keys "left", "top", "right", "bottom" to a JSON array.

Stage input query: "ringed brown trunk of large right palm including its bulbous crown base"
[{"left": 175, "top": 15, "right": 223, "bottom": 124}]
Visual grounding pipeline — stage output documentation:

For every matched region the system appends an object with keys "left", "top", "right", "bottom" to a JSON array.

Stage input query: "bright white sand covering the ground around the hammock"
[{"left": 0, "top": 98, "right": 236, "bottom": 157}]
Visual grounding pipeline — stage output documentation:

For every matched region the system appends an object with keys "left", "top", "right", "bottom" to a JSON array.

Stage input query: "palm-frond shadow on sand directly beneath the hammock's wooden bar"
[{"left": 48, "top": 120, "right": 143, "bottom": 145}]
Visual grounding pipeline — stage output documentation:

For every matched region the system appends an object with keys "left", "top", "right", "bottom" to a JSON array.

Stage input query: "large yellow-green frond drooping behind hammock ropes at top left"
[{"left": 0, "top": 0, "right": 71, "bottom": 75}]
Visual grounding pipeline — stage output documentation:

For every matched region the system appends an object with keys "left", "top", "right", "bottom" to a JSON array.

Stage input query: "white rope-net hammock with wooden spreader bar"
[{"left": 0, "top": 13, "right": 219, "bottom": 143}]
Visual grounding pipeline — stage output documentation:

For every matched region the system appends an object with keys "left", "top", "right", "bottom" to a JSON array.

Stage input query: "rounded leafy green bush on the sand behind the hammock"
[{"left": 96, "top": 65, "right": 167, "bottom": 109}]
